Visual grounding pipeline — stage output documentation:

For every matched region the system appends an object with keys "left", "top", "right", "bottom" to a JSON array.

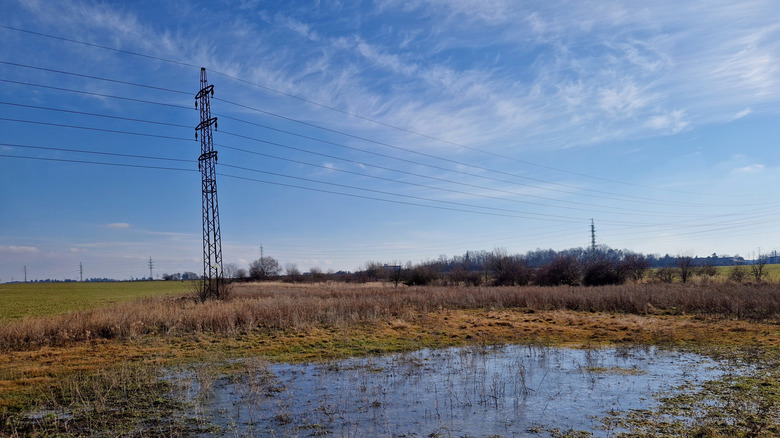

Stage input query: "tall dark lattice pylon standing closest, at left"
[{"left": 195, "top": 68, "right": 223, "bottom": 299}]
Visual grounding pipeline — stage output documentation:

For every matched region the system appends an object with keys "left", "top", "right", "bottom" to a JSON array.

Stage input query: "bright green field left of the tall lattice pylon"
[{"left": 0, "top": 281, "right": 192, "bottom": 321}]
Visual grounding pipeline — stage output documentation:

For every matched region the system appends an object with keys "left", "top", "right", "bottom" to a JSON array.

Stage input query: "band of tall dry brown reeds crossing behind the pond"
[{"left": 0, "top": 283, "right": 780, "bottom": 351}]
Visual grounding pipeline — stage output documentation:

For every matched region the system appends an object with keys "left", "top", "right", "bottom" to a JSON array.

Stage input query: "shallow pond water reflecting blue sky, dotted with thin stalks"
[{"left": 195, "top": 345, "right": 719, "bottom": 437}]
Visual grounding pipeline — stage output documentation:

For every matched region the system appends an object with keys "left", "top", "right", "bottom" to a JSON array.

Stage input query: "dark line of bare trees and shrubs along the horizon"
[{"left": 225, "top": 246, "right": 769, "bottom": 286}]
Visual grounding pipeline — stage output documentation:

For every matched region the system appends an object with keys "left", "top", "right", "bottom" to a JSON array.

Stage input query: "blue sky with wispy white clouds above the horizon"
[{"left": 0, "top": 0, "right": 780, "bottom": 282}]
